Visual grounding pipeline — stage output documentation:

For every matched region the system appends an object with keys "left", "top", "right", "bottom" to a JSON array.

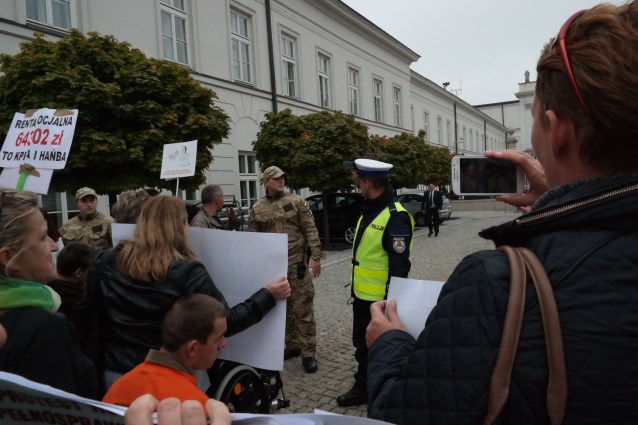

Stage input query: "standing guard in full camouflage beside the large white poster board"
[{"left": 248, "top": 166, "right": 321, "bottom": 373}]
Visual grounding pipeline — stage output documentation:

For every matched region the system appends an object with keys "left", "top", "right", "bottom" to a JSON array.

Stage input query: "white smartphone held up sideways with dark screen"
[{"left": 452, "top": 155, "right": 526, "bottom": 196}]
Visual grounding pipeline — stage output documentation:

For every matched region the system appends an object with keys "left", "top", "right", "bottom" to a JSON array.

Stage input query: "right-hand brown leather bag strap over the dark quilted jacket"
[{"left": 518, "top": 247, "right": 567, "bottom": 425}]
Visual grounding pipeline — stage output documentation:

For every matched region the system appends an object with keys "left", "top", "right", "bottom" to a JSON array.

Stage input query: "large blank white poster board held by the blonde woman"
[{"left": 112, "top": 224, "right": 288, "bottom": 370}]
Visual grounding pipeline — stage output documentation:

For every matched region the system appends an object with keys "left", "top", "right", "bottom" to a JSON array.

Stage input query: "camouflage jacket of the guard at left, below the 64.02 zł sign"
[{"left": 60, "top": 212, "right": 114, "bottom": 250}]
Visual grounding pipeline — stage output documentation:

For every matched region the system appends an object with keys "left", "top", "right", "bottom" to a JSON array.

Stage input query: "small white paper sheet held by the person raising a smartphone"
[{"left": 388, "top": 276, "right": 444, "bottom": 338}]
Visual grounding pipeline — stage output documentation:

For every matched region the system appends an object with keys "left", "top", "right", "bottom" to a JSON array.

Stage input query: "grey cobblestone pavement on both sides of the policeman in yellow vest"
[{"left": 280, "top": 211, "right": 518, "bottom": 417}]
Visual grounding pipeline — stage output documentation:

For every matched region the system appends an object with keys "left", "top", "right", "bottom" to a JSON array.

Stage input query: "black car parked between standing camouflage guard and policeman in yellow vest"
[{"left": 306, "top": 193, "right": 363, "bottom": 244}]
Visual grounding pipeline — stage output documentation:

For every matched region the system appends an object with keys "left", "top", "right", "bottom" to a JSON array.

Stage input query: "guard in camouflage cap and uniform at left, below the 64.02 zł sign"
[{"left": 60, "top": 187, "right": 113, "bottom": 250}]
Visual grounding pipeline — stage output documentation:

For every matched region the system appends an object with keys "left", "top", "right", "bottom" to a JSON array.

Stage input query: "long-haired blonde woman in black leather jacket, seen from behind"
[{"left": 88, "top": 196, "right": 290, "bottom": 388}]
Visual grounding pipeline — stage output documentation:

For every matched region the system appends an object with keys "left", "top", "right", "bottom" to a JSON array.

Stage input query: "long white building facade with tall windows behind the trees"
[{"left": 0, "top": 0, "right": 508, "bottom": 225}]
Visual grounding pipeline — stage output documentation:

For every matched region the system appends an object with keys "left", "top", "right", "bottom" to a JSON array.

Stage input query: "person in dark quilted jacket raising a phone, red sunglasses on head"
[{"left": 366, "top": 3, "right": 638, "bottom": 424}]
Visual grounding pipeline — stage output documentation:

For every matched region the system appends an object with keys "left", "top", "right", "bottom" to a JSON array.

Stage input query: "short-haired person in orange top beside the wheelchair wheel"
[{"left": 103, "top": 294, "right": 227, "bottom": 406}]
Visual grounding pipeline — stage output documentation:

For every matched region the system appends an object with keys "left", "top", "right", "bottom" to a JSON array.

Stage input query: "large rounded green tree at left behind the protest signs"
[{"left": 0, "top": 30, "right": 230, "bottom": 194}]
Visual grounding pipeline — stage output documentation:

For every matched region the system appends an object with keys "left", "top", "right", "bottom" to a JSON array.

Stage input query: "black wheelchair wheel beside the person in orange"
[{"left": 215, "top": 365, "right": 270, "bottom": 413}]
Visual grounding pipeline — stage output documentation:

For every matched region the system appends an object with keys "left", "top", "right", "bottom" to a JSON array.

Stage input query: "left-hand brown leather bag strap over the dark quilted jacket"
[{"left": 483, "top": 246, "right": 526, "bottom": 425}]
